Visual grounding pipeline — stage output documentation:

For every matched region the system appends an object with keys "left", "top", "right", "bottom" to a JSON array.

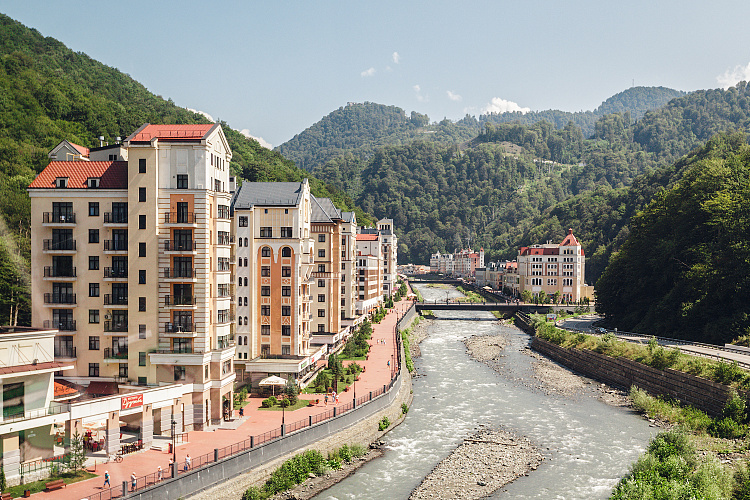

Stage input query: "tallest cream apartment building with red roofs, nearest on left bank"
[{"left": 28, "top": 124, "right": 235, "bottom": 430}]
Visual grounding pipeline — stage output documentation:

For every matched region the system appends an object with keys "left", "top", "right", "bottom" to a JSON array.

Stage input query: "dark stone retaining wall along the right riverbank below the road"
[{"left": 536, "top": 336, "right": 730, "bottom": 416}]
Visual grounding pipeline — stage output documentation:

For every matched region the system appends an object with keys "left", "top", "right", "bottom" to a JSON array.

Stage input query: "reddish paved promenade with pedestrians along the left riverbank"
[{"left": 32, "top": 300, "right": 411, "bottom": 500}]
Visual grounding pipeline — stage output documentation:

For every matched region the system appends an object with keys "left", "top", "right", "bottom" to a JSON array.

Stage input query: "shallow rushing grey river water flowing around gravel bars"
[{"left": 317, "top": 286, "right": 654, "bottom": 499}]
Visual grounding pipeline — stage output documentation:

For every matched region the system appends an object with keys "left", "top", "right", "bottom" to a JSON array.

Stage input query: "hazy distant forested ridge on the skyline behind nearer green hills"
[{"left": 276, "top": 87, "right": 685, "bottom": 171}]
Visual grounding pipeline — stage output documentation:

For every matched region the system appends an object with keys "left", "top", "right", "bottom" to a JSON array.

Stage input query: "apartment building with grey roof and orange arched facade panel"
[{"left": 232, "top": 179, "right": 324, "bottom": 383}]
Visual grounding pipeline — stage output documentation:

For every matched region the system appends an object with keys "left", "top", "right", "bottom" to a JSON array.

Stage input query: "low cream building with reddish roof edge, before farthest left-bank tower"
[{"left": 356, "top": 232, "right": 383, "bottom": 314}]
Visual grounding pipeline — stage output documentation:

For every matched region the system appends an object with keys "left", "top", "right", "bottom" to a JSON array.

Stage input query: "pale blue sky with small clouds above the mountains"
[{"left": 0, "top": 0, "right": 750, "bottom": 147}]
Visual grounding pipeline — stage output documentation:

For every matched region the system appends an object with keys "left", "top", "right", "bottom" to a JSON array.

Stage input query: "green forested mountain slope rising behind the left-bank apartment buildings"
[{"left": 0, "top": 14, "right": 364, "bottom": 324}]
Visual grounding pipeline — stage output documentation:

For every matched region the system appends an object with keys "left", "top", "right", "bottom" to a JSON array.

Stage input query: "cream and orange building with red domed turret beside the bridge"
[{"left": 517, "top": 229, "right": 588, "bottom": 301}]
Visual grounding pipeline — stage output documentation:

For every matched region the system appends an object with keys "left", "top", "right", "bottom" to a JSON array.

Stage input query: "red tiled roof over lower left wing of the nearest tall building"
[{"left": 29, "top": 161, "right": 128, "bottom": 189}]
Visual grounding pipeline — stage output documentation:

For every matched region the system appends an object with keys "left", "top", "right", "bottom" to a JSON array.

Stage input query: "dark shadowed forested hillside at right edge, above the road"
[{"left": 596, "top": 133, "right": 750, "bottom": 344}]
